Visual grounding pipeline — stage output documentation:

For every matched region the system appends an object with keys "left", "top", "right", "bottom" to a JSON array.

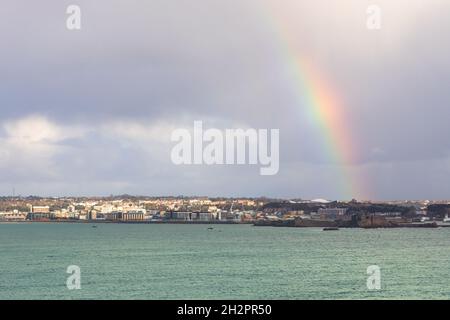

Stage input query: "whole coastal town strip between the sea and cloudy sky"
[{"left": 0, "top": 195, "right": 450, "bottom": 230}]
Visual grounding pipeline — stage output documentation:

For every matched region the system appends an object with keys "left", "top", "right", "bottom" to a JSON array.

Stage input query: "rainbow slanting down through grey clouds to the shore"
[{"left": 266, "top": 8, "right": 368, "bottom": 200}]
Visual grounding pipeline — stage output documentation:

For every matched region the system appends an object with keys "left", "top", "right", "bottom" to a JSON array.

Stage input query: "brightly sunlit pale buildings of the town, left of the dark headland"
[{"left": 0, "top": 198, "right": 264, "bottom": 222}]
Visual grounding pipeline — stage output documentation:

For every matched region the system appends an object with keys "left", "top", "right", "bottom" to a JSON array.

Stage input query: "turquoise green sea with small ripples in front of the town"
[{"left": 0, "top": 223, "right": 450, "bottom": 299}]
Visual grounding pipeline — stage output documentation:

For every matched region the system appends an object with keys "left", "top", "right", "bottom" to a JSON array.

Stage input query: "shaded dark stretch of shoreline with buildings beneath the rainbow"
[{"left": 255, "top": 200, "right": 450, "bottom": 228}]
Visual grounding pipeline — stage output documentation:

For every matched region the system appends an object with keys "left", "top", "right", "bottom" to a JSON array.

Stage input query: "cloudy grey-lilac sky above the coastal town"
[{"left": 0, "top": 0, "right": 450, "bottom": 200}]
